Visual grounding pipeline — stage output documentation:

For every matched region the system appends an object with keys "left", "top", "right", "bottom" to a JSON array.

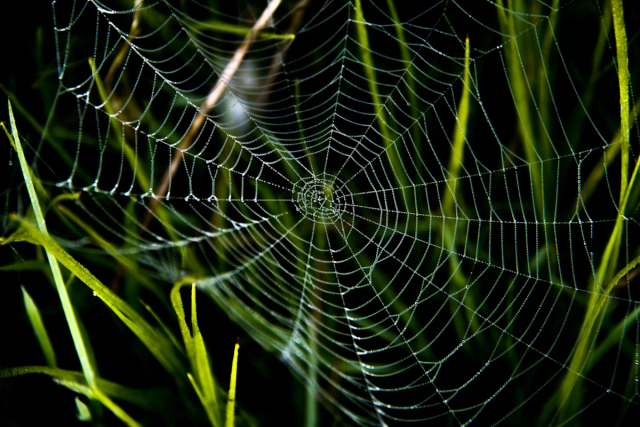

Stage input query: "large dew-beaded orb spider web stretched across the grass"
[{"left": 48, "top": 0, "right": 640, "bottom": 425}]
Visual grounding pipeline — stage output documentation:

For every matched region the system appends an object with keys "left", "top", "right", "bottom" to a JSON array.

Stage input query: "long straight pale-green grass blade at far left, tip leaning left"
[{"left": 8, "top": 101, "right": 96, "bottom": 387}]
